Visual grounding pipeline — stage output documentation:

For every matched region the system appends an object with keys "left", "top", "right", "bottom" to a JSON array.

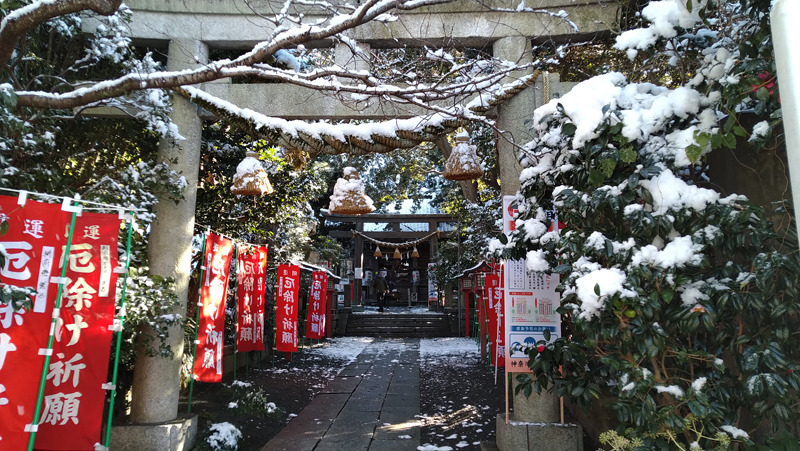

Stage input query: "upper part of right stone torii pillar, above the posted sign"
[{"left": 493, "top": 36, "right": 536, "bottom": 195}]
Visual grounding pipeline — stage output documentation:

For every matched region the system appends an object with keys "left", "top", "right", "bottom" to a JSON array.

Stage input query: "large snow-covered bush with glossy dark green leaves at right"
[{"left": 504, "top": 0, "right": 800, "bottom": 449}]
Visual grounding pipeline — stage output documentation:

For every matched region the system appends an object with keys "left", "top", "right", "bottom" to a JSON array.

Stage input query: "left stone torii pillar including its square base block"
[{"left": 111, "top": 39, "right": 208, "bottom": 451}]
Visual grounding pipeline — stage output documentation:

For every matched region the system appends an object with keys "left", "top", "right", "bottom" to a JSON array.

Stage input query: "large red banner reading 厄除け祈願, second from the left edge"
[{"left": 35, "top": 213, "right": 120, "bottom": 450}]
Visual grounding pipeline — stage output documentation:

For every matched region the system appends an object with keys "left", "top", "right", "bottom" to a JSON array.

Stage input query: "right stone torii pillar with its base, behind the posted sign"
[{"left": 493, "top": 36, "right": 583, "bottom": 451}]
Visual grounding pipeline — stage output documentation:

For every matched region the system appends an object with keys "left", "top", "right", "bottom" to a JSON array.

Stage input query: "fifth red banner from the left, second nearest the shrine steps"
[{"left": 275, "top": 265, "right": 300, "bottom": 352}]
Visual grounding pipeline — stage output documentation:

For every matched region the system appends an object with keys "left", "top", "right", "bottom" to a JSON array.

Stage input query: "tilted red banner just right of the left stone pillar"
[{"left": 194, "top": 233, "right": 233, "bottom": 382}]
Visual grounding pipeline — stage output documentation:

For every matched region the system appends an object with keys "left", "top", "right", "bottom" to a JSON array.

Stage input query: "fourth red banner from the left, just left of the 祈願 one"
[{"left": 236, "top": 246, "right": 267, "bottom": 352}]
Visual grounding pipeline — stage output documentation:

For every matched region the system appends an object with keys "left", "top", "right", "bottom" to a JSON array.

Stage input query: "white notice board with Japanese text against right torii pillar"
[{"left": 504, "top": 260, "right": 561, "bottom": 372}]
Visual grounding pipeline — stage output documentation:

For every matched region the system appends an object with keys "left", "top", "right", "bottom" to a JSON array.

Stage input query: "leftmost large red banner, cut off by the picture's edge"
[{"left": 0, "top": 196, "right": 70, "bottom": 450}]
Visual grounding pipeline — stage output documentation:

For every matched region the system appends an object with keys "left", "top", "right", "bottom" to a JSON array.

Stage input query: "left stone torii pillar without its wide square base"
[{"left": 124, "top": 40, "right": 208, "bottom": 442}]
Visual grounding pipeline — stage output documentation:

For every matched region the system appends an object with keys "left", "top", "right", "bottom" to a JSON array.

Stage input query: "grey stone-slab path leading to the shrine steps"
[{"left": 263, "top": 338, "right": 420, "bottom": 451}]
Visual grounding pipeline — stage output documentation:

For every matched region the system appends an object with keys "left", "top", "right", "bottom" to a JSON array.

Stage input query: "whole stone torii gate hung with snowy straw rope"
[{"left": 104, "top": 0, "right": 617, "bottom": 450}]
